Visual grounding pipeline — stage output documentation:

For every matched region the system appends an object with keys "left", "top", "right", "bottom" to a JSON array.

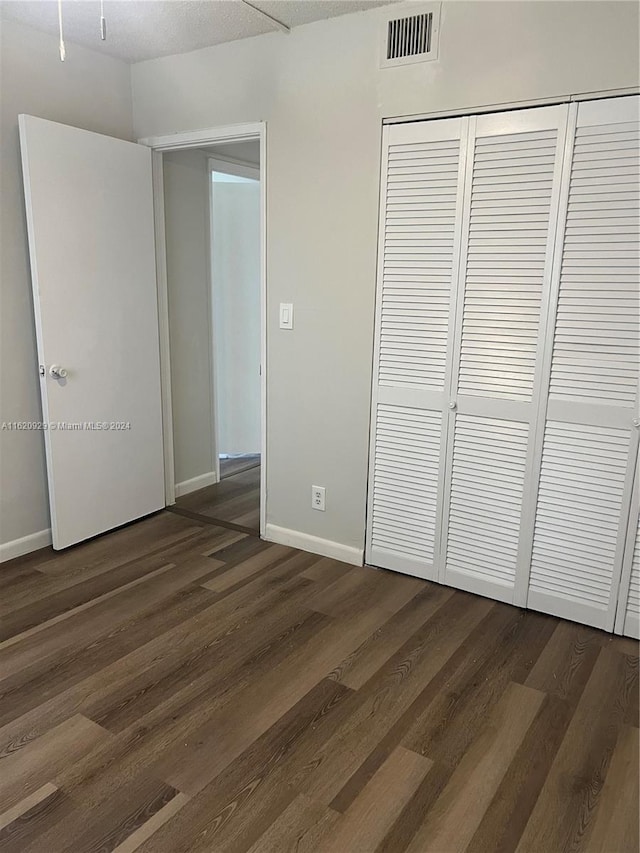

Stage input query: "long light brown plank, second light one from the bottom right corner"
[{"left": 407, "top": 683, "right": 544, "bottom": 853}]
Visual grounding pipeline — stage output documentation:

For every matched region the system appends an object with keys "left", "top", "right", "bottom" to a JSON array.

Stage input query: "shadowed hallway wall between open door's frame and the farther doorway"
[{"left": 163, "top": 151, "right": 215, "bottom": 484}]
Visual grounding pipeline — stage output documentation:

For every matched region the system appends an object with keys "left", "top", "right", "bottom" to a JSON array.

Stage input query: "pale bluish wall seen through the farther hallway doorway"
[{"left": 211, "top": 175, "right": 260, "bottom": 454}]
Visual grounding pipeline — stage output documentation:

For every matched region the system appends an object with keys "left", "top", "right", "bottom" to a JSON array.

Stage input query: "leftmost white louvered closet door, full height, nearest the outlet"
[{"left": 366, "top": 119, "right": 467, "bottom": 578}]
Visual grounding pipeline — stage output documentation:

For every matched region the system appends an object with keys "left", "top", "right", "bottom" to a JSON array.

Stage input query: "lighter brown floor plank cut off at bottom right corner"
[{"left": 586, "top": 726, "right": 640, "bottom": 853}]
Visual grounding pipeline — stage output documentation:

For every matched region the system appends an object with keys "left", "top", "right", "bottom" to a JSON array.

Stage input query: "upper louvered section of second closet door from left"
[{"left": 458, "top": 127, "right": 558, "bottom": 401}]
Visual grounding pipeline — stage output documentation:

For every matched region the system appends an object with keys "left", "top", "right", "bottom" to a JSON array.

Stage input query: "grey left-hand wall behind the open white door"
[{"left": 0, "top": 20, "right": 132, "bottom": 558}]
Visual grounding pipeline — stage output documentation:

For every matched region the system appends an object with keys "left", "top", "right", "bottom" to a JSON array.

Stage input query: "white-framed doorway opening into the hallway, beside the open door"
[{"left": 142, "top": 125, "right": 266, "bottom": 535}]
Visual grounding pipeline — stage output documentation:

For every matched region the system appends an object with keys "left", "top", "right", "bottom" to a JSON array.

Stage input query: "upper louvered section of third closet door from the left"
[{"left": 550, "top": 115, "right": 640, "bottom": 406}]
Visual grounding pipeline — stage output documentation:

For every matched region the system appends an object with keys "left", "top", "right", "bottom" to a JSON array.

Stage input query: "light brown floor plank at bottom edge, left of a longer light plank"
[{"left": 317, "top": 746, "right": 432, "bottom": 853}]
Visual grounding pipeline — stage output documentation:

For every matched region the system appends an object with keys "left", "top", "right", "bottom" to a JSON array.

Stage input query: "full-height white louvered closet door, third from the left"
[{"left": 528, "top": 97, "right": 640, "bottom": 630}]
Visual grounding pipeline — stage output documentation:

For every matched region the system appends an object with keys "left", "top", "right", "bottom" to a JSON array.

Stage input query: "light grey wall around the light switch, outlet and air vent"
[{"left": 132, "top": 0, "right": 638, "bottom": 548}]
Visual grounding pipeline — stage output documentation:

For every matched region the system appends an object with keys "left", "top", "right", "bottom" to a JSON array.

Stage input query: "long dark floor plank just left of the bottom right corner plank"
[{"left": 517, "top": 649, "right": 638, "bottom": 853}]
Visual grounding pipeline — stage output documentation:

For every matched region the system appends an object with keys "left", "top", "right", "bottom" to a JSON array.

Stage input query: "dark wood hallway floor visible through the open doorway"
[{"left": 173, "top": 457, "right": 260, "bottom": 533}]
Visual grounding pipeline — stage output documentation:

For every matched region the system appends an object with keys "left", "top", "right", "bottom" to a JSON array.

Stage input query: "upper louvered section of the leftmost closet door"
[{"left": 378, "top": 139, "right": 460, "bottom": 390}]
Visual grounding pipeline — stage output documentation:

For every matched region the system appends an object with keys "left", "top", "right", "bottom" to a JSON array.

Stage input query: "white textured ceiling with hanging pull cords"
[{"left": 0, "top": 0, "right": 394, "bottom": 62}]
